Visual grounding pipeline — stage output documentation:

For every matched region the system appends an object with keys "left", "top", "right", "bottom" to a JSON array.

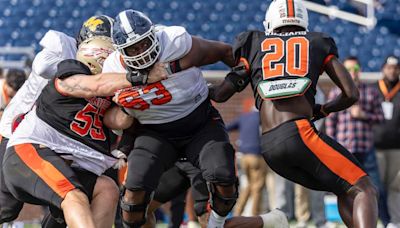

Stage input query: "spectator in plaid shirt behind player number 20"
[{"left": 326, "top": 57, "right": 390, "bottom": 226}]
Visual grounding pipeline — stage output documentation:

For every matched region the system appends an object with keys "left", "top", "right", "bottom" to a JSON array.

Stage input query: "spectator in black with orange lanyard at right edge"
[{"left": 374, "top": 56, "right": 400, "bottom": 227}]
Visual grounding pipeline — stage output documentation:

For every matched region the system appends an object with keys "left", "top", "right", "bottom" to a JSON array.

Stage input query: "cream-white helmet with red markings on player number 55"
[{"left": 76, "top": 36, "right": 115, "bottom": 74}]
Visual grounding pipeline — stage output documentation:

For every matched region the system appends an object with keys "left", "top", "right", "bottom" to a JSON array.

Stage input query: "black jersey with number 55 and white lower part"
[{"left": 7, "top": 59, "right": 116, "bottom": 175}]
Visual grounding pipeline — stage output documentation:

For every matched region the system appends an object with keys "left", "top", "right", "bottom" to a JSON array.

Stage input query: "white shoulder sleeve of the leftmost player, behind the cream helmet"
[{"left": 32, "top": 30, "right": 76, "bottom": 79}]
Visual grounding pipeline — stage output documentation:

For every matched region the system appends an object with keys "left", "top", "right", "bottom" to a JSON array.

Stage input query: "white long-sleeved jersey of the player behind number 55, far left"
[{"left": 0, "top": 30, "right": 76, "bottom": 138}]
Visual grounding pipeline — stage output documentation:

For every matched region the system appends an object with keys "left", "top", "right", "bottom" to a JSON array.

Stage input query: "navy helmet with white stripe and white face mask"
[{"left": 112, "top": 10, "right": 160, "bottom": 70}]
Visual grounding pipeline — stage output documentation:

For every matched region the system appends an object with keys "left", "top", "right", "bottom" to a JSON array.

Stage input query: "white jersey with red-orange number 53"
[{"left": 103, "top": 26, "right": 208, "bottom": 124}]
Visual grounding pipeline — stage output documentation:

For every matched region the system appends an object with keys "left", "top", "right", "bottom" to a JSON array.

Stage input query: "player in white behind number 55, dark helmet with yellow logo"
[{"left": 0, "top": 15, "right": 112, "bottom": 224}]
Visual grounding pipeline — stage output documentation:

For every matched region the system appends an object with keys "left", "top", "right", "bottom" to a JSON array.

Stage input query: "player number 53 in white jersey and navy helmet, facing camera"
[{"left": 60, "top": 10, "right": 237, "bottom": 227}]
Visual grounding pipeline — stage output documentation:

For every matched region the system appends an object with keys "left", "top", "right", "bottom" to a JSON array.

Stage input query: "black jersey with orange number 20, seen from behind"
[{"left": 233, "top": 31, "right": 338, "bottom": 109}]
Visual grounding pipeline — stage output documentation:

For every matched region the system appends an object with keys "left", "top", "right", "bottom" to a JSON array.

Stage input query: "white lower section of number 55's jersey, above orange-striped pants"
[{"left": 7, "top": 107, "right": 117, "bottom": 176}]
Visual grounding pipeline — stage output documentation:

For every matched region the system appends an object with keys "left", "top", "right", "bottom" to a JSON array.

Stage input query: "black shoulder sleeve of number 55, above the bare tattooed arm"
[{"left": 56, "top": 59, "right": 92, "bottom": 79}]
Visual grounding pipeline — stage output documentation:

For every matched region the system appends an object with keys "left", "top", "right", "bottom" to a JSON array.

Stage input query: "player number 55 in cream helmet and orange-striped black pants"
[{"left": 3, "top": 36, "right": 125, "bottom": 227}]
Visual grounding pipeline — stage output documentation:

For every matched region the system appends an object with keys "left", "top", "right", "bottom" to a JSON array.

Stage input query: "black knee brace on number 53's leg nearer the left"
[{"left": 120, "top": 188, "right": 154, "bottom": 228}]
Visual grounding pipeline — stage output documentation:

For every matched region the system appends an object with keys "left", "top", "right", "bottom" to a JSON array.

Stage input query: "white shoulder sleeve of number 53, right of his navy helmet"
[{"left": 156, "top": 26, "right": 192, "bottom": 62}]
